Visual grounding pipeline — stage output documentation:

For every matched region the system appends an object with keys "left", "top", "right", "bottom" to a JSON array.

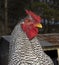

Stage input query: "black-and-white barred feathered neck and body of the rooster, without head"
[{"left": 8, "top": 23, "right": 54, "bottom": 65}]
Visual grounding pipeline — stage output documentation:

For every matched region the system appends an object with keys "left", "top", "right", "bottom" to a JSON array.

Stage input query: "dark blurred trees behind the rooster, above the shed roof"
[{"left": 0, "top": 0, "right": 59, "bottom": 36}]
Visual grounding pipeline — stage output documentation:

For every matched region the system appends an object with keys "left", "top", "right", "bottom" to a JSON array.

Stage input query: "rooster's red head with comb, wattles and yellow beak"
[{"left": 21, "top": 11, "right": 42, "bottom": 40}]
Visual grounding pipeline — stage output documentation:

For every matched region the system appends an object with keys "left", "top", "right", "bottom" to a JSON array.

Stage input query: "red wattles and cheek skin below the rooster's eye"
[{"left": 21, "top": 24, "right": 38, "bottom": 40}]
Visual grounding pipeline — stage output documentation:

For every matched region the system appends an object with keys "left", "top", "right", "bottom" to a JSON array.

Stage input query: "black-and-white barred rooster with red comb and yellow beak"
[{"left": 8, "top": 10, "right": 54, "bottom": 65}]
